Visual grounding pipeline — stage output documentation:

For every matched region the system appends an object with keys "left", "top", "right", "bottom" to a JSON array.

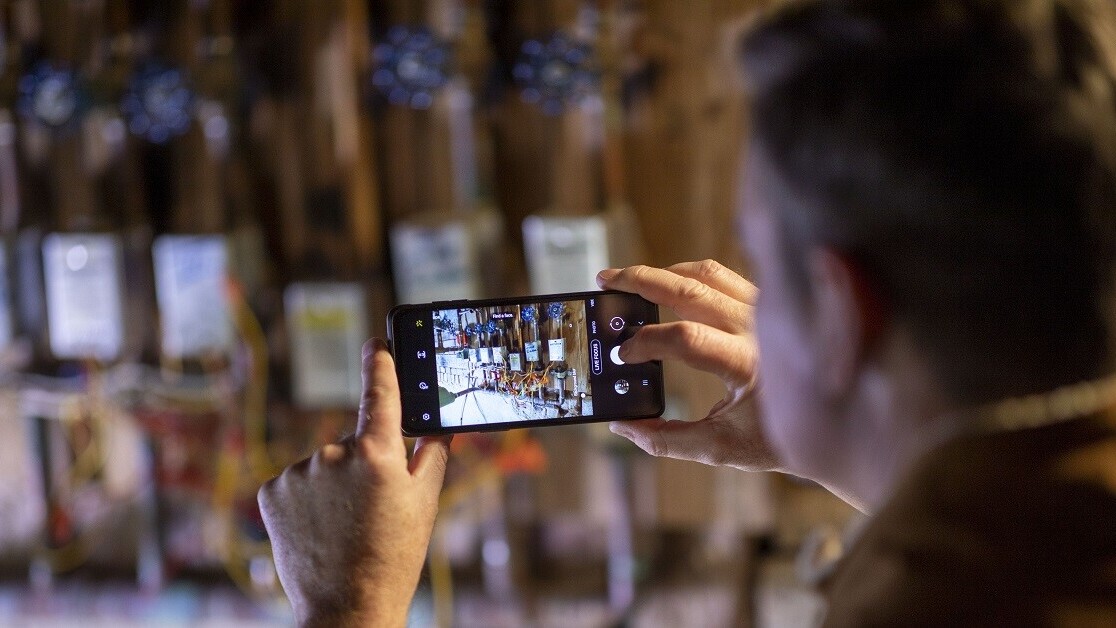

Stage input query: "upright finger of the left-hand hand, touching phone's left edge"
[{"left": 356, "top": 338, "right": 406, "bottom": 454}]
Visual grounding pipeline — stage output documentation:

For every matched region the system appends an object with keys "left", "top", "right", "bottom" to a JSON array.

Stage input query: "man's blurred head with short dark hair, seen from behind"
[{"left": 743, "top": 0, "right": 1116, "bottom": 481}]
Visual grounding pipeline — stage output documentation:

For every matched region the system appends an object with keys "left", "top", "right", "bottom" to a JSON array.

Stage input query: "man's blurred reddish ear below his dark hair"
[{"left": 808, "top": 248, "right": 886, "bottom": 396}]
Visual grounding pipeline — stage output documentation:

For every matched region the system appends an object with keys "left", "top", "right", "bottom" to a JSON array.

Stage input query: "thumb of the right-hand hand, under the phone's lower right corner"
[{"left": 608, "top": 418, "right": 720, "bottom": 464}]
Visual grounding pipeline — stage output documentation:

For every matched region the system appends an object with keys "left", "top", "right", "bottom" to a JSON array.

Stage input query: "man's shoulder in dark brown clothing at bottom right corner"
[{"left": 828, "top": 423, "right": 1116, "bottom": 626}]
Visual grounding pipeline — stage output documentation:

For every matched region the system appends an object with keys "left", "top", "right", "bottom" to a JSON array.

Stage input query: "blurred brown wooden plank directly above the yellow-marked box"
[{"left": 259, "top": 0, "right": 382, "bottom": 280}]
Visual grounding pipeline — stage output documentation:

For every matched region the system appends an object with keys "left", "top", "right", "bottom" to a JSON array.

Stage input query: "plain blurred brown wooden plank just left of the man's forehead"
[{"left": 625, "top": 0, "right": 758, "bottom": 264}]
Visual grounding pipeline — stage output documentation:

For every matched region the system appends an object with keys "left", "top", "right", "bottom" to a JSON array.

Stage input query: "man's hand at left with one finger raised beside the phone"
[{"left": 259, "top": 340, "right": 449, "bottom": 626}]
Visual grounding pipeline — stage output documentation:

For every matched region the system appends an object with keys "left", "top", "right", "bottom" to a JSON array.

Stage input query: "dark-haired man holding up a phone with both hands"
[{"left": 260, "top": 0, "right": 1116, "bottom": 626}]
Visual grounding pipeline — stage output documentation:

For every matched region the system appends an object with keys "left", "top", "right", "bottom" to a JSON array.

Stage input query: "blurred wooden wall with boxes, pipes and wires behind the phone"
[{"left": 0, "top": 0, "right": 857, "bottom": 627}]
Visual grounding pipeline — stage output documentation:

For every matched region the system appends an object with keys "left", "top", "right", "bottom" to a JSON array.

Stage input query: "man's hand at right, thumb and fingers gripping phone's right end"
[{"left": 597, "top": 260, "right": 779, "bottom": 471}]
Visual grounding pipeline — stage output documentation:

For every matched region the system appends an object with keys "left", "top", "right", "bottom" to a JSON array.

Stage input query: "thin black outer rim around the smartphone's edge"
[{"left": 387, "top": 290, "right": 666, "bottom": 437}]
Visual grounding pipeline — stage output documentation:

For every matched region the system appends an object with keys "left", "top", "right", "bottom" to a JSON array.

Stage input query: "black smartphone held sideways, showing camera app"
[{"left": 387, "top": 291, "right": 664, "bottom": 436}]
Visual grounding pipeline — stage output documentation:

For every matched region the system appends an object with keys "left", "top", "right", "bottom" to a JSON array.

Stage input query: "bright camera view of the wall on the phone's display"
[{"left": 433, "top": 300, "right": 593, "bottom": 426}]
